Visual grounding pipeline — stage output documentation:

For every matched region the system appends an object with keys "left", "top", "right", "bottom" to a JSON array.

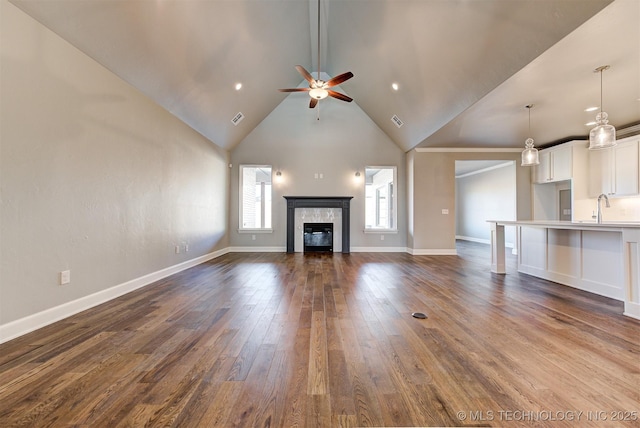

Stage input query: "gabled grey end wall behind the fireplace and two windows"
[{"left": 230, "top": 86, "right": 407, "bottom": 251}]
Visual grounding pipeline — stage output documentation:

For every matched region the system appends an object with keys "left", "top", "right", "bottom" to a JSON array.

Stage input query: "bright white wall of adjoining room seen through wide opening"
[{"left": 456, "top": 162, "right": 516, "bottom": 246}]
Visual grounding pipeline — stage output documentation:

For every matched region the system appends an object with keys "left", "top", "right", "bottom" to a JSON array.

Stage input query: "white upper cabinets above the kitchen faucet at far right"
[{"left": 589, "top": 136, "right": 640, "bottom": 198}]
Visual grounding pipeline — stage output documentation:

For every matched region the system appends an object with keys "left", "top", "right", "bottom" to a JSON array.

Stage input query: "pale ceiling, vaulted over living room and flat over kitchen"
[{"left": 11, "top": 0, "right": 640, "bottom": 151}]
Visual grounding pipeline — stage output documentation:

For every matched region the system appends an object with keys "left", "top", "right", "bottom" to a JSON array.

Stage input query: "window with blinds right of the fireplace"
[{"left": 364, "top": 166, "right": 397, "bottom": 230}]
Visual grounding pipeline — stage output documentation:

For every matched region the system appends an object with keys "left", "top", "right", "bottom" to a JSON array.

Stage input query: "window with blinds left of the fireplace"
[{"left": 240, "top": 165, "right": 271, "bottom": 230}]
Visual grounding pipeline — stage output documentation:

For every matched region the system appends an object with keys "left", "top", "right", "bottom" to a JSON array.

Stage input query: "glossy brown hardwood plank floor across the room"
[{"left": 0, "top": 242, "right": 640, "bottom": 427}]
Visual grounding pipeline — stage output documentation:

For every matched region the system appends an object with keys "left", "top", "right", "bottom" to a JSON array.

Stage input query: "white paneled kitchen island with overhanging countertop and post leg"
[{"left": 489, "top": 220, "right": 640, "bottom": 319}]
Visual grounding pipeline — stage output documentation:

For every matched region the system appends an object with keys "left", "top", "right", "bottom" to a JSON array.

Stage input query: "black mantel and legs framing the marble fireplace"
[{"left": 284, "top": 196, "right": 353, "bottom": 254}]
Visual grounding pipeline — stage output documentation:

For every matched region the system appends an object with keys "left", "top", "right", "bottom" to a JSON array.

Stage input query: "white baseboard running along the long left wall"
[{"left": 0, "top": 248, "right": 229, "bottom": 343}]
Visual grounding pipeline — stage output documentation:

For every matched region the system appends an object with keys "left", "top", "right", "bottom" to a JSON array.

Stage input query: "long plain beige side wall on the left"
[{"left": 0, "top": 0, "right": 229, "bottom": 341}]
